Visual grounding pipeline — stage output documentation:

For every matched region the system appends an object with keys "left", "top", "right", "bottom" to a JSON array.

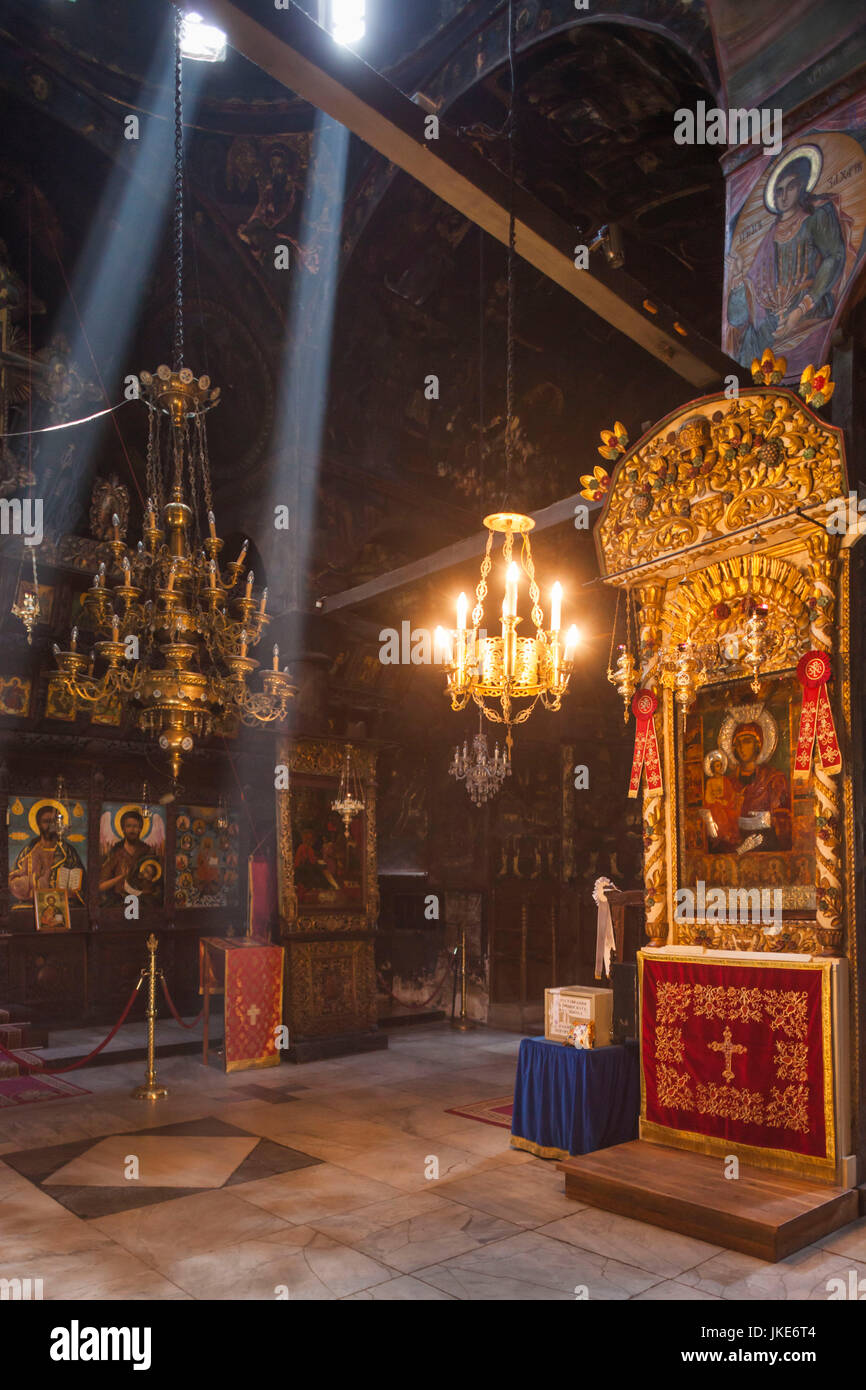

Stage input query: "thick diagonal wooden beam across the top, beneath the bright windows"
[{"left": 179, "top": 0, "right": 746, "bottom": 391}]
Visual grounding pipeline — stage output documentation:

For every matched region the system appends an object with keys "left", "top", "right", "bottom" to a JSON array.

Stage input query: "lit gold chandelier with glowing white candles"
[{"left": 436, "top": 512, "right": 578, "bottom": 755}]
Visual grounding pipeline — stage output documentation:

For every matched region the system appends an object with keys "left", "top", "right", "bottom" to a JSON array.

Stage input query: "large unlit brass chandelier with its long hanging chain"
[{"left": 50, "top": 10, "right": 295, "bottom": 781}]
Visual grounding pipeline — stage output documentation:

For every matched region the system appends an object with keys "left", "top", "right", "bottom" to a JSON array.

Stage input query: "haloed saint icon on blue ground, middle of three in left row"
[{"left": 99, "top": 802, "right": 165, "bottom": 910}]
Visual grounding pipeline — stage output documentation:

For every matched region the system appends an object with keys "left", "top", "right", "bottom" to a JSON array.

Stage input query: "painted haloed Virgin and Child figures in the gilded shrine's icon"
[{"left": 701, "top": 705, "right": 791, "bottom": 856}]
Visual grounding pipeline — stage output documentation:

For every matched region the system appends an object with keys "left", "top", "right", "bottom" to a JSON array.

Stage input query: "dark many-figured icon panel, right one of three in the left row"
[{"left": 174, "top": 806, "right": 240, "bottom": 908}]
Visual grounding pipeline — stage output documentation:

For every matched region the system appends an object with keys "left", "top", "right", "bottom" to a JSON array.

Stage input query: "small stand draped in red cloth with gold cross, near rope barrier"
[{"left": 199, "top": 937, "right": 284, "bottom": 1072}]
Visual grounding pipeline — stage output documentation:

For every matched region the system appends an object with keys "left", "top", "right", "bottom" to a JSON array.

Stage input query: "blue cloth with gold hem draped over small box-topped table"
[{"left": 512, "top": 1038, "right": 641, "bottom": 1158}]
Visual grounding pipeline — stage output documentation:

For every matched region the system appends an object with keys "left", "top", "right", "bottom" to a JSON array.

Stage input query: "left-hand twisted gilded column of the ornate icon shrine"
[{"left": 638, "top": 584, "right": 669, "bottom": 947}]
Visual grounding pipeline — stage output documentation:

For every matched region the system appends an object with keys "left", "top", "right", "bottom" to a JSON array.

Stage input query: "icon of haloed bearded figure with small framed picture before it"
[{"left": 8, "top": 796, "right": 88, "bottom": 909}]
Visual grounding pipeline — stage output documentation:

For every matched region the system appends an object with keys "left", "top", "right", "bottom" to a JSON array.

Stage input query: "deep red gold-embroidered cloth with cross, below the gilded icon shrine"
[{"left": 639, "top": 952, "right": 835, "bottom": 1170}]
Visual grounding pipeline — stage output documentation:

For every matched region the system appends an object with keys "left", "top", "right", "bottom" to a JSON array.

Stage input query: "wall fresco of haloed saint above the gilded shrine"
[{"left": 724, "top": 103, "right": 866, "bottom": 381}]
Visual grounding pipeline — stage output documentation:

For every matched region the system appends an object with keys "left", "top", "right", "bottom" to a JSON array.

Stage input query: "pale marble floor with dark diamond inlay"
[{"left": 0, "top": 1023, "right": 866, "bottom": 1300}]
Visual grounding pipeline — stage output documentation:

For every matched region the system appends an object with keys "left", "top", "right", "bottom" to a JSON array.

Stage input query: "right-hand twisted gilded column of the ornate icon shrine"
[{"left": 806, "top": 531, "right": 844, "bottom": 956}]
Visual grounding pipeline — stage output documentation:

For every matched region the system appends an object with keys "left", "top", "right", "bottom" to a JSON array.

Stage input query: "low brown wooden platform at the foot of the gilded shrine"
[{"left": 556, "top": 1140, "right": 859, "bottom": 1262}]
